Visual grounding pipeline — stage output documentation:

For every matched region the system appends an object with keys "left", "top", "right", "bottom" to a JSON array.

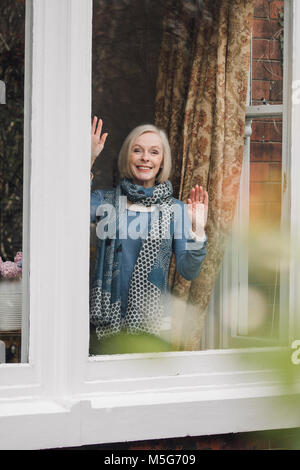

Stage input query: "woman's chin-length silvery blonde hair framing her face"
[{"left": 118, "top": 124, "right": 172, "bottom": 183}]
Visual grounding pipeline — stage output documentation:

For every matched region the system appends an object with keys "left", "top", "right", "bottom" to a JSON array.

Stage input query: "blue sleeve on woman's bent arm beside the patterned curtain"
[{"left": 173, "top": 203, "right": 207, "bottom": 281}]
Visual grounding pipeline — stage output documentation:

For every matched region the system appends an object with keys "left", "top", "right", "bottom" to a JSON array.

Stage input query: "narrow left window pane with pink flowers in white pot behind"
[{"left": 0, "top": 0, "right": 25, "bottom": 363}]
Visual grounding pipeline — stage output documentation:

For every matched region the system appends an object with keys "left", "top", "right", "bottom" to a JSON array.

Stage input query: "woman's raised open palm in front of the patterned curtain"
[{"left": 187, "top": 184, "right": 208, "bottom": 237}]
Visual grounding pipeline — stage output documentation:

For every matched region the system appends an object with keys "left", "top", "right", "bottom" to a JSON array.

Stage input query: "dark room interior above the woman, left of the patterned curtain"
[{"left": 92, "top": 0, "right": 165, "bottom": 188}]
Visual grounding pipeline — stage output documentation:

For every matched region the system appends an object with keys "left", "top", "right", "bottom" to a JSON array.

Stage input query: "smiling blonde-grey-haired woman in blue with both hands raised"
[{"left": 90, "top": 116, "right": 208, "bottom": 348}]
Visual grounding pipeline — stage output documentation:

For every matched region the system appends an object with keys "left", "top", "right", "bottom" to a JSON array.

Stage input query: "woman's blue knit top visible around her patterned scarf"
[{"left": 90, "top": 189, "right": 207, "bottom": 315}]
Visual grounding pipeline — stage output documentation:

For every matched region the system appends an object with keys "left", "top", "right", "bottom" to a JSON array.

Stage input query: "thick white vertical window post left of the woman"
[{"left": 29, "top": 0, "right": 91, "bottom": 396}]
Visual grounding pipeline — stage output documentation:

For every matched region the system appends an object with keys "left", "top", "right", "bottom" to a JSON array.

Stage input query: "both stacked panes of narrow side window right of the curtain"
[{"left": 244, "top": 0, "right": 284, "bottom": 339}]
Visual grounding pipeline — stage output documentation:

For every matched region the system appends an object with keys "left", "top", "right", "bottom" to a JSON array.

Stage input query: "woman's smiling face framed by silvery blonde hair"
[{"left": 129, "top": 132, "right": 163, "bottom": 188}]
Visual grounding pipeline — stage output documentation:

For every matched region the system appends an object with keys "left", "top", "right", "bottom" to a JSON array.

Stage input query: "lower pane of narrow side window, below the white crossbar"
[{"left": 248, "top": 118, "right": 282, "bottom": 338}]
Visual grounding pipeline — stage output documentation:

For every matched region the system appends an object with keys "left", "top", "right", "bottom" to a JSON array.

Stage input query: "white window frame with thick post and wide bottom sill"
[{"left": 0, "top": 0, "right": 300, "bottom": 449}]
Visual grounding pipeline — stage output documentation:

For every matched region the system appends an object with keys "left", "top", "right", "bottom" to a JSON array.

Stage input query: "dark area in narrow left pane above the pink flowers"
[{"left": 0, "top": 0, "right": 25, "bottom": 261}]
